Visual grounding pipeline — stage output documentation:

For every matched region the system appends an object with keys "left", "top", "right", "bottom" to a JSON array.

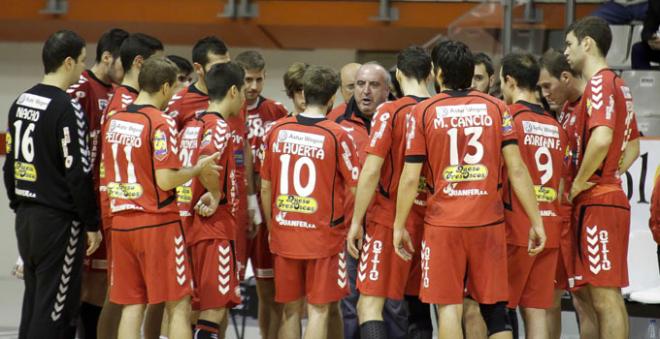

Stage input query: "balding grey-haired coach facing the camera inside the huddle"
[{"left": 328, "top": 61, "right": 408, "bottom": 339}]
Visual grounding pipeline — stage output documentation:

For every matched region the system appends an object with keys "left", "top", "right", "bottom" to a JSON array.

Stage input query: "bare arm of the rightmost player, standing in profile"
[{"left": 568, "top": 126, "right": 612, "bottom": 201}]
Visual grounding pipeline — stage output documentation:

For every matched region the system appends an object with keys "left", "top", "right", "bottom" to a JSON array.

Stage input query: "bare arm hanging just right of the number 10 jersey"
[{"left": 346, "top": 154, "right": 385, "bottom": 258}]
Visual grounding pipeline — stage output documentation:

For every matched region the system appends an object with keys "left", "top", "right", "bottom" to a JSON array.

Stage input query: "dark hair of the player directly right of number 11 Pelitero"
[{"left": 204, "top": 62, "right": 245, "bottom": 101}]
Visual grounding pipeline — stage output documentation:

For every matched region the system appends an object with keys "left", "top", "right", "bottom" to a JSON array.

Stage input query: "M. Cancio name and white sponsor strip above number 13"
[{"left": 433, "top": 104, "right": 493, "bottom": 129}]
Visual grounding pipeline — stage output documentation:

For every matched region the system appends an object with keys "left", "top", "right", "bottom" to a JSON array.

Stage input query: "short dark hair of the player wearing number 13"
[{"left": 432, "top": 40, "right": 474, "bottom": 89}]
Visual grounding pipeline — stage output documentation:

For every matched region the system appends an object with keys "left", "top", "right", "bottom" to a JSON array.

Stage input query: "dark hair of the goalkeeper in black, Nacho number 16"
[{"left": 41, "top": 29, "right": 85, "bottom": 74}]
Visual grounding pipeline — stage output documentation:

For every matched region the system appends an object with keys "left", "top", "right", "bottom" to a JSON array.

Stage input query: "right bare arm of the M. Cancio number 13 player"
[{"left": 502, "top": 144, "right": 547, "bottom": 255}]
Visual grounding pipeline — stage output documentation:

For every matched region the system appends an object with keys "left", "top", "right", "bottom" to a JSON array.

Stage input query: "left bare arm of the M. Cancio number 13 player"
[{"left": 393, "top": 162, "right": 424, "bottom": 261}]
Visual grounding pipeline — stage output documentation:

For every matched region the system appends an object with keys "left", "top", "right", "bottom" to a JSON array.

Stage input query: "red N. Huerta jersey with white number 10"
[{"left": 261, "top": 115, "right": 359, "bottom": 259}]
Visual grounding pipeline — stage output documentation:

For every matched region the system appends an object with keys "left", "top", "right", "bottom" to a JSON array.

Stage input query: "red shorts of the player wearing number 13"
[{"left": 419, "top": 223, "right": 508, "bottom": 305}]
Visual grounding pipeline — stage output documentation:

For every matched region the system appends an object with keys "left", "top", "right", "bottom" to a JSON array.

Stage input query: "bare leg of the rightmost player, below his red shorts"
[{"left": 588, "top": 285, "right": 629, "bottom": 339}]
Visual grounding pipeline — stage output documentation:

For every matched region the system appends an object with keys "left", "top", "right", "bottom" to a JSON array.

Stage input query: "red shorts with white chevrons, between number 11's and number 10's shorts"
[{"left": 190, "top": 239, "right": 241, "bottom": 311}]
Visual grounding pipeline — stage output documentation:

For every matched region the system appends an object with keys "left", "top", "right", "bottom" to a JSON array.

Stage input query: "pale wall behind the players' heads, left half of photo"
[{"left": 0, "top": 42, "right": 355, "bottom": 278}]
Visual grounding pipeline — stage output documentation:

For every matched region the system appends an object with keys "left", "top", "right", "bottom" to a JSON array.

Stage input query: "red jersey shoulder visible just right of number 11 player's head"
[{"left": 165, "top": 84, "right": 209, "bottom": 129}]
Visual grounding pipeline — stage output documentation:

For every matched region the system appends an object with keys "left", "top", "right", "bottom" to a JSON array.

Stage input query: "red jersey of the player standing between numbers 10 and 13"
[{"left": 361, "top": 96, "right": 426, "bottom": 227}]
